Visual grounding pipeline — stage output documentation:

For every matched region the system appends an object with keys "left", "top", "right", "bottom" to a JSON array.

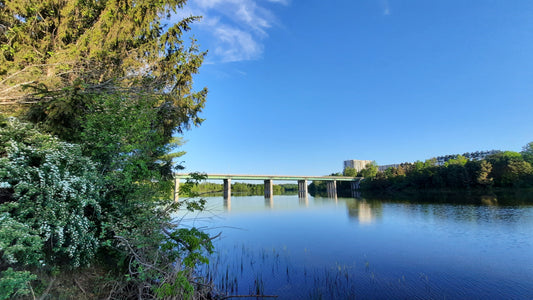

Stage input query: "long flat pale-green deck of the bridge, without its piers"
[{"left": 175, "top": 174, "right": 363, "bottom": 181}]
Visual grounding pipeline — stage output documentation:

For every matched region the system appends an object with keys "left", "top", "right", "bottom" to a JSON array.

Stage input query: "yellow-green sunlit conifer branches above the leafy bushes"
[{"left": 0, "top": 0, "right": 207, "bottom": 136}]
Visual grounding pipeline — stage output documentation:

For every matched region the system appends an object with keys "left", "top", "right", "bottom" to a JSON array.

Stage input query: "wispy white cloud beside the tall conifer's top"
[{"left": 180, "top": 0, "right": 289, "bottom": 62}]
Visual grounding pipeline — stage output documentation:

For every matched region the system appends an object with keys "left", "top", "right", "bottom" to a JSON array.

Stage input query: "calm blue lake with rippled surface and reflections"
[{"left": 179, "top": 196, "right": 533, "bottom": 299}]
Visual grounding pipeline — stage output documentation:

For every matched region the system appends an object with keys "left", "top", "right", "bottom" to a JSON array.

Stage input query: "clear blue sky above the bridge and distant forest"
[{"left": 177, "top": 0, "right": 533, "bottom": 175}]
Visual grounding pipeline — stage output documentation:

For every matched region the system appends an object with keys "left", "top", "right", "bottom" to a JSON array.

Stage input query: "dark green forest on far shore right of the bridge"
[{"left": 361, "top": 142, "right": 533, "bottom": 190}]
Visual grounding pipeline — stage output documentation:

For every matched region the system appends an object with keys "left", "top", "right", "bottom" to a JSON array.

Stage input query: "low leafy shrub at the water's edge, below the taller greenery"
[{"left": 115, "top": 204, "right": 213, "bottom": 299}]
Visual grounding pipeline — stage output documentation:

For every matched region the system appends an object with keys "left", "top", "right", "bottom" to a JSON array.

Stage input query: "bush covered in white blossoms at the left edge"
[{"left": 0, "top": 118, "right": 101, "bottom": 268}]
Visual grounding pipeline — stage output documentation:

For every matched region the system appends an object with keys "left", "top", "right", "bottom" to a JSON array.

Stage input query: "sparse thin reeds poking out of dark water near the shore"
[{"left": 196, "top": 244, "right": 441, "bottom": 299}]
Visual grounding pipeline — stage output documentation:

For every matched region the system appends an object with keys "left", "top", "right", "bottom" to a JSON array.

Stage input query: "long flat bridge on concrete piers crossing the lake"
[{"left": 174, "top": 174, "right": 363, "bottom": 201}]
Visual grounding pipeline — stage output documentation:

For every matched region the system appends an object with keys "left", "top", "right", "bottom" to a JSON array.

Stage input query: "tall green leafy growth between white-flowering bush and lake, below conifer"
[{"left": 51, "top": 94, "right": 212, "bottom": 297}]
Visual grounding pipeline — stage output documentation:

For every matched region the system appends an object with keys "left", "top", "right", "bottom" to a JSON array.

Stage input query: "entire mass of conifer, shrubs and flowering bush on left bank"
[{"left": 0, "top": 0, "right": 212, "bottom": 298}]
